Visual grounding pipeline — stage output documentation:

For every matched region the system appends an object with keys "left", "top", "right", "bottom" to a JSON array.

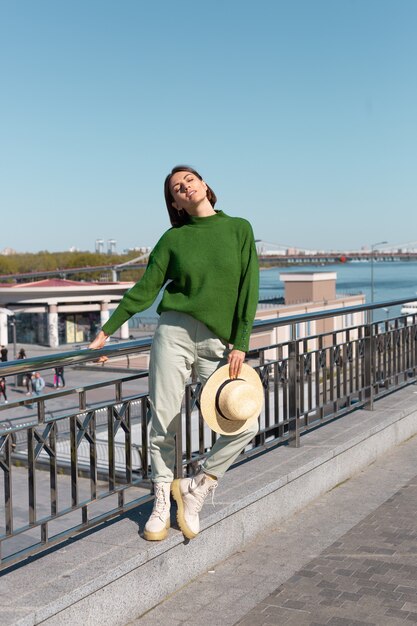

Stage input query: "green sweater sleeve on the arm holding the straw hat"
[{"left": 233, "top": 222, "right": 259, "bottom": 352}]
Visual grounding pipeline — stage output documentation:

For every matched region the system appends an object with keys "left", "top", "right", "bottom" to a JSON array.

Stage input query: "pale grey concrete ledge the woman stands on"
[{"left": 0, "top": 385, "right": 417, "bottom": 626}]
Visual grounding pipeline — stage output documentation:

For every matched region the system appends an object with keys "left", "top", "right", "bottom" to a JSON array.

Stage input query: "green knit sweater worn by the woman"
[{"left": 103, "top": 211, "right": 259, "bottom": 352}]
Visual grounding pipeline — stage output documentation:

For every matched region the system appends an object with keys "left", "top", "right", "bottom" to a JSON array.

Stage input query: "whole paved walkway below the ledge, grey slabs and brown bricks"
[{"left": 130, "top": 428, "right": 417, "bottom": 626}]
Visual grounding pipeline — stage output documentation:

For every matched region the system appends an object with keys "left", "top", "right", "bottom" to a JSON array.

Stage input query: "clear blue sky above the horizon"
[{"left": 0, "top": 0, "right": 417, "bottom": 252}]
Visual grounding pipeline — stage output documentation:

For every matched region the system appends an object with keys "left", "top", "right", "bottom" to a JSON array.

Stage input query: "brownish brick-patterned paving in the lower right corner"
[{"left": 236, "top": 477, "right": 417, "bottom": 626}]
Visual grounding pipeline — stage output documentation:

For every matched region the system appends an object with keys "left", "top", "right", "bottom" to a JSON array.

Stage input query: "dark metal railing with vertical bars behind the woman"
[{"left": 0, "top": 300, "right": 417, "bottom": 568}]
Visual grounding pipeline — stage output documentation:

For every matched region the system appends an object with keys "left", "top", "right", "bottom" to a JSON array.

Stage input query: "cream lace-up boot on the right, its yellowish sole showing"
[{"left": 171, "top": 472, "right": 218, "bottom": 539}]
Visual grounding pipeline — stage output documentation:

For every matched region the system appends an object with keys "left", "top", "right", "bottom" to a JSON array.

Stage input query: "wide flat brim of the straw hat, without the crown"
[{"left": 200, "top": 363, "right": 263, "bottom": 435}]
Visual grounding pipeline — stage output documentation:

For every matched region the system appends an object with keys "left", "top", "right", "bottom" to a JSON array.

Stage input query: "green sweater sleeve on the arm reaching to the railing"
[{"left": 103, "top": 244, "right": 168, "bottom": 335}]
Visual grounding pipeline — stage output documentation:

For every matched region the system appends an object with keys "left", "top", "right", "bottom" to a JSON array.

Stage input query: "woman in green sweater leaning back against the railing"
[{"left": 90, "top": 165, "right": 259, "bottom": 541}]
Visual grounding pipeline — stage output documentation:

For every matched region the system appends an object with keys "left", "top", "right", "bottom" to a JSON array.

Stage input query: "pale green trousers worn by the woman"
[{"left": 149, "top": 311, "right": 258, "bottom": 482}]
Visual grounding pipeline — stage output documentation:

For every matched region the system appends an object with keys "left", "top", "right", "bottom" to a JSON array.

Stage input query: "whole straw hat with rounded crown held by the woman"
[{"left": 200, "top": 363, "right": 263, "bottom": 435}]
